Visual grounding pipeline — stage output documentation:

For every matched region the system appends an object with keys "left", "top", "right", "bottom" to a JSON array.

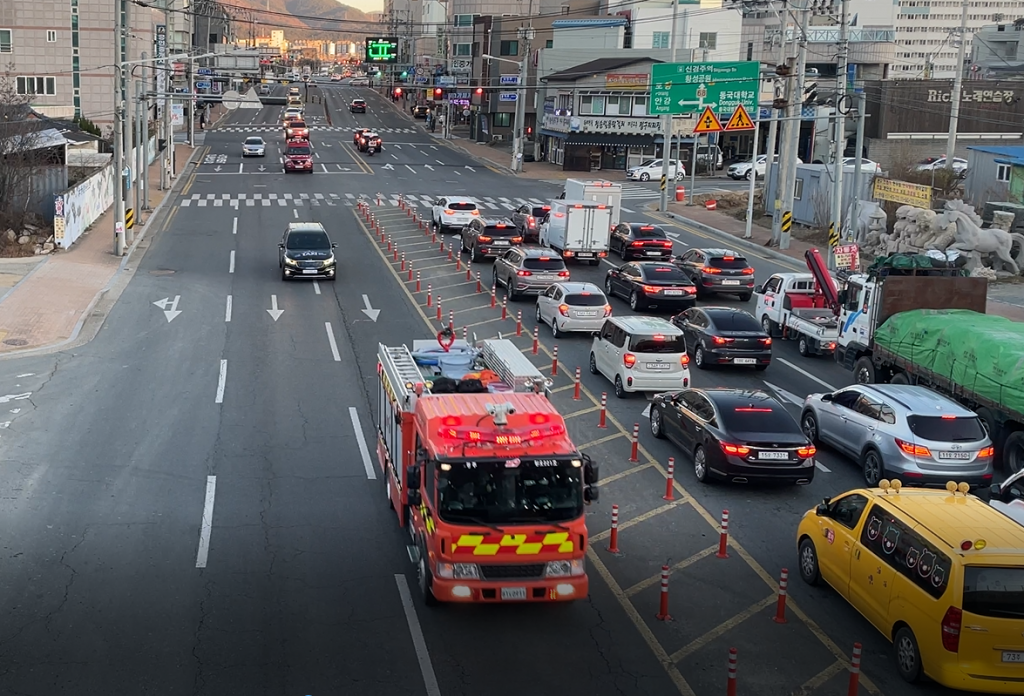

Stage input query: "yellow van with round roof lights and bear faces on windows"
[{"left": 797, "top": 480, "right": 1024, "bottom": 694}]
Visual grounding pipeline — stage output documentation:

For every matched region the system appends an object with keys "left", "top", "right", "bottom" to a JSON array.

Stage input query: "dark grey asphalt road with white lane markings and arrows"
[{"left": 0, "top": 78, "right": 962, "bottom": 696}]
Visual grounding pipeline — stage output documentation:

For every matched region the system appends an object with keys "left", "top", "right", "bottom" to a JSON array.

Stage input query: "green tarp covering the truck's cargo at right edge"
[{"left": 874, "top": 309, "right": 1024, "bottom": 414}]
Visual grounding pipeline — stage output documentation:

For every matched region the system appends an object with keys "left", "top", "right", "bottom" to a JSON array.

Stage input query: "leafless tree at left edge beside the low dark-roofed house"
[{"left": 0, "top": 72, "right": 48, "bottom": 233}]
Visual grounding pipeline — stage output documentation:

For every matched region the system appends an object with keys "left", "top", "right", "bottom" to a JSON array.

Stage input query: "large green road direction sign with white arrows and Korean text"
[{"left": 650, "top": 60, "right": 761, "bottom": 118}]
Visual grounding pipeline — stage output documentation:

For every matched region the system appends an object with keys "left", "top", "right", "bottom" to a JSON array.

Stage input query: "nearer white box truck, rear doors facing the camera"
[{"left": 540, "top": 201, "right": 612, "bottom": 266}]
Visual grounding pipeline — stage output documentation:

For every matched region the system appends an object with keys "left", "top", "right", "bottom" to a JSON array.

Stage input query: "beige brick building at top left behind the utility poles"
[{"left": 0, "top": 0, "right": 161, "bottom": 128}]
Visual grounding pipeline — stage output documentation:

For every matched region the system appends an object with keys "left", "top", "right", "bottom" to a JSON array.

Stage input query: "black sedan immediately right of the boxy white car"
[{"left": 672, "top": 307, "right": 771, "bottom": 369}]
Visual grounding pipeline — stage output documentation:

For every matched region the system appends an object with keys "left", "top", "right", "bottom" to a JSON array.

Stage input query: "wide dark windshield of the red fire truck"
[{"left": 437, "top": 459, "right": 583, "bottom": 524}]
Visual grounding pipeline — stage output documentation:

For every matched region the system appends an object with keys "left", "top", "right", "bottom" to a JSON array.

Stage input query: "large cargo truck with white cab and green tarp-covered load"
[{"left": 836, "top": 256, "right": 1024, "bottom": 473}]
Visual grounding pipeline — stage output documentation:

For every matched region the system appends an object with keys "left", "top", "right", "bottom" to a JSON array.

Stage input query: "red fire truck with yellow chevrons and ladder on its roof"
[{"left": 377, "top": 335, "right": 598, "bottom": 605}]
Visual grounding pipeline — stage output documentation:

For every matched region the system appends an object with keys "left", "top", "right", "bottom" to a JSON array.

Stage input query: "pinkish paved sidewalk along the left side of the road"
[{"left": 0, "top": 142, "right": 199, "bottom": 356}]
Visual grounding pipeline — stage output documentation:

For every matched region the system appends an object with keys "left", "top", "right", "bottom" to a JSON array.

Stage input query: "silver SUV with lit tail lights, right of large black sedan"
[{"left": 800, "top": 384, "right": 993, "bottom": 487}]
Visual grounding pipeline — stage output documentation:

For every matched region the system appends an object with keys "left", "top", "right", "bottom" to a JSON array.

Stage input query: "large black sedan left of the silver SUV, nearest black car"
[{"left": 650, "top": 388, "right": 816, "bottom": 485}]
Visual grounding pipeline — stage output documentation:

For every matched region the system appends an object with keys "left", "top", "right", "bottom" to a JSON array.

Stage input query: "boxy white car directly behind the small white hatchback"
[{"left": 590, "top": 316, "right": 690, "bottom": 399}]
